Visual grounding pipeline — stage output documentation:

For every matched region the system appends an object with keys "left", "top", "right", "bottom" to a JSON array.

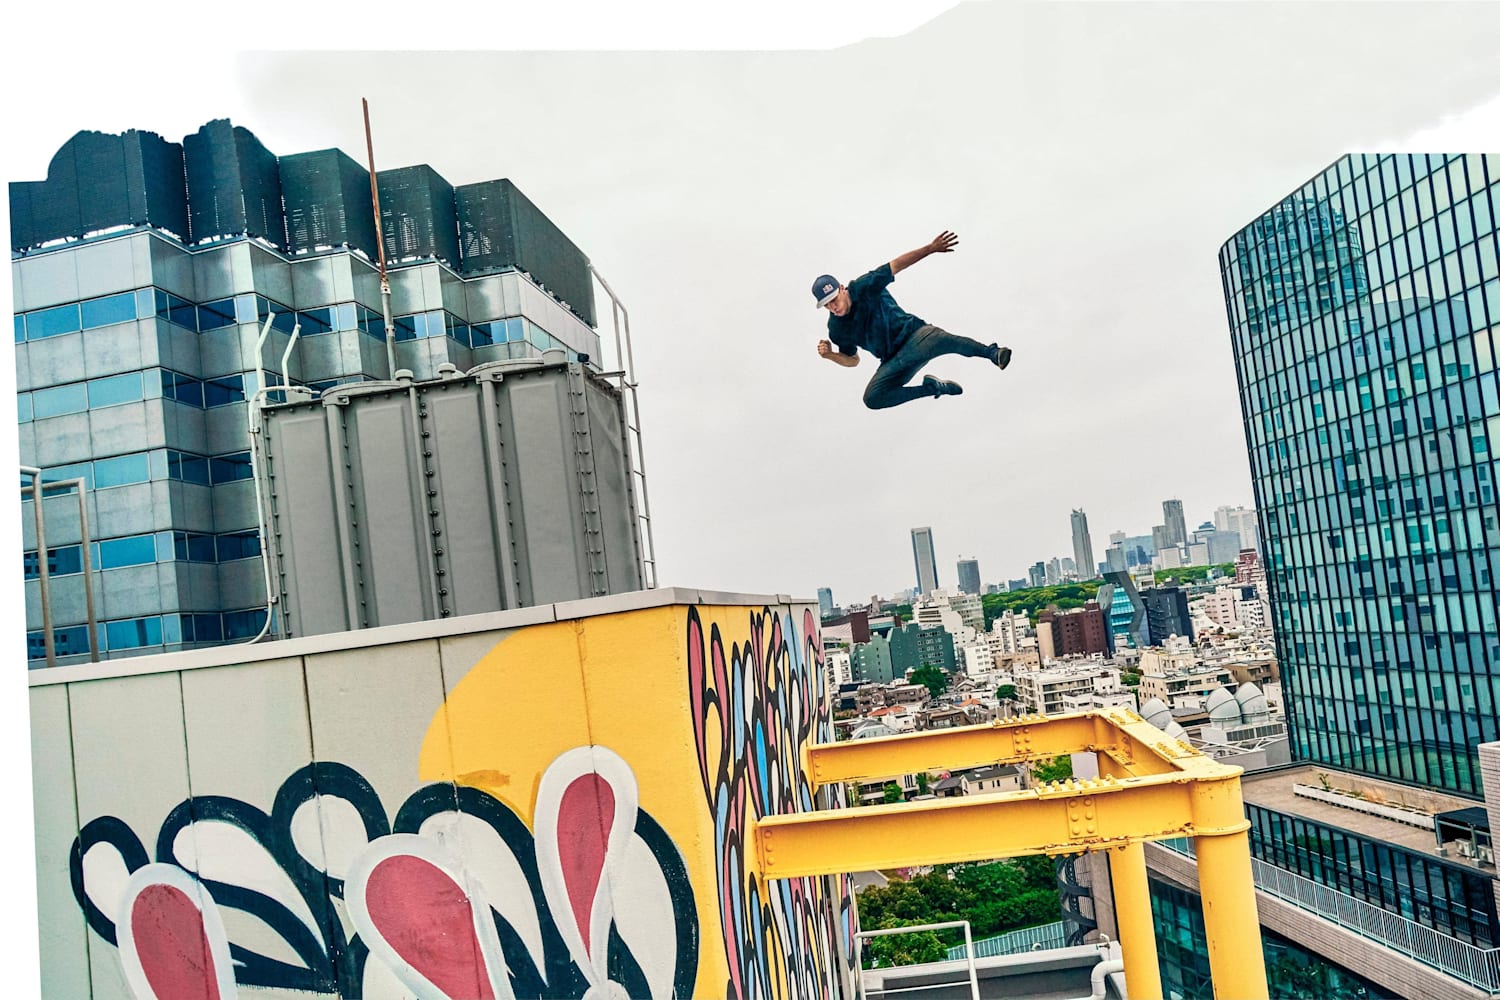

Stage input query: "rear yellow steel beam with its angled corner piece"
[{"left": 807, "top": 709, "right": 1223, "bottom": 787}]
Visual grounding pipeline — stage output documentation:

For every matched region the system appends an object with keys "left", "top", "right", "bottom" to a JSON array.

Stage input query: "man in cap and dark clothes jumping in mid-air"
[{"left": 813, "top": 231, "right": 1011, "bottom": 409}]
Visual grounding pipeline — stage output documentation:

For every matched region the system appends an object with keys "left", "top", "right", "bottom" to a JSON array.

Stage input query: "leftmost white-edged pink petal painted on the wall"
[{"left": 116, "top": 864, "right": 239, "bottom": 1000}]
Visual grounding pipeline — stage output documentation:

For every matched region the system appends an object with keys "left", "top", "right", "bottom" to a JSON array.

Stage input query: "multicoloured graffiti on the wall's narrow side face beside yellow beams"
[{"left": 686, "top": 609, "right": 855, "bottom": 1000}]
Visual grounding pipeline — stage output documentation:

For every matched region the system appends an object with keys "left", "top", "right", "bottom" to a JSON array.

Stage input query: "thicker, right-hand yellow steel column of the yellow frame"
[{"left": 1193, "top": 777, "right": 1269, "bottom": 1000}]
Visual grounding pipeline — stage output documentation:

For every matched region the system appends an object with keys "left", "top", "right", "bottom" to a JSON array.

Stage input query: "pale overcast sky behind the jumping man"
[{"left": 0, "top": 0, "right": 1500, "bottom": 993}]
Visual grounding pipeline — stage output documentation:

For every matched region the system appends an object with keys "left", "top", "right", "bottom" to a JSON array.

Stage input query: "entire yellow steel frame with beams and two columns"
[{"left": 774, "top": 709, "right": 1268, "bottom": 1000}]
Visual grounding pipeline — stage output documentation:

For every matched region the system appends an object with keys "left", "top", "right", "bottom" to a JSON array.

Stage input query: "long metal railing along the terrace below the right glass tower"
[{"left": 1158, "top": 840, "right": 1500, "bottom": 996}]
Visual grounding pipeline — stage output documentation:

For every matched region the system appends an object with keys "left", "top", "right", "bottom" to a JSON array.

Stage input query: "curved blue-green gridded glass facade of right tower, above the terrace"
[{"left": 1220, "top": 154, "right": 1500, "bottom": 796}]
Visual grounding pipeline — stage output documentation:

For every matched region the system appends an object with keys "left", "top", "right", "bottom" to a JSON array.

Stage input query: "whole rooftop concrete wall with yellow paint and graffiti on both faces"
[{"left": 30, "top": 589, "right": 854, "bottom": 1000}]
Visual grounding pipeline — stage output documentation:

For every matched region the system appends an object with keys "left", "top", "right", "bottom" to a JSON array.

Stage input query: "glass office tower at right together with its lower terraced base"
[{"left": 1148, "top": 153, "right": 1500, "bottom": 997}]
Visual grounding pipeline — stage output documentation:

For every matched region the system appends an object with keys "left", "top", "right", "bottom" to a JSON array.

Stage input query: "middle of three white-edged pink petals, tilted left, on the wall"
[{"left": 344, "top": 834, "right": 513, "bottom": 1000}]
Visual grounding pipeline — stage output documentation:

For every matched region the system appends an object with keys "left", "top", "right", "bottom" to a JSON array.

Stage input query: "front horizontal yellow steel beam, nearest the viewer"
[{"left": 755, "top": 768, "right": 1250, "bottom": 879}]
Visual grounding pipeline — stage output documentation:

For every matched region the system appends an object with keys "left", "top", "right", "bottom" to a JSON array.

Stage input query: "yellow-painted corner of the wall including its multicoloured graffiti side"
[{"left": 420, "top": 606, "right": 854, "bottom": 999}]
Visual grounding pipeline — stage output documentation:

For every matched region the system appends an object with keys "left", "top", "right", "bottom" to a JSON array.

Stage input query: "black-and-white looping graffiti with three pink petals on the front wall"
[{"left": 69, "top": 745, "right": 699, "bottom": 1000}]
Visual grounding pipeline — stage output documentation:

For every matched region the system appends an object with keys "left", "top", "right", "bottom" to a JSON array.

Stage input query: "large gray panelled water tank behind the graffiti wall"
[{"left": 261, "top": 357, "right": 642, "bottom": 637}]
